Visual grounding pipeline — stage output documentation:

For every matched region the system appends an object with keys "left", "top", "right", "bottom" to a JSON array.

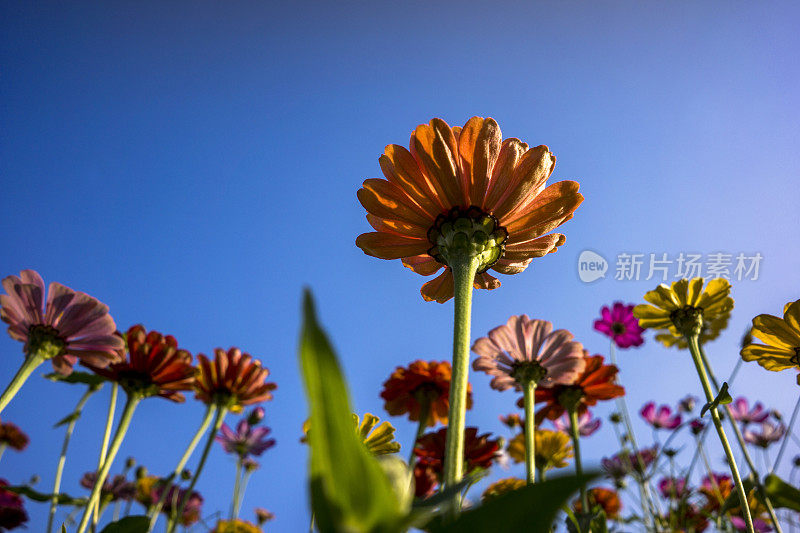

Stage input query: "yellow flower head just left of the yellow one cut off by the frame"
[{"left": 633, "top": 278, "right": 733, "bottom": 336}]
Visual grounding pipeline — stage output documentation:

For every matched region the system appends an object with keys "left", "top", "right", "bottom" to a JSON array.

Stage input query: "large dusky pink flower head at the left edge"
[{"left": 0, "top": 270, "right": 124, "bottom": 375}]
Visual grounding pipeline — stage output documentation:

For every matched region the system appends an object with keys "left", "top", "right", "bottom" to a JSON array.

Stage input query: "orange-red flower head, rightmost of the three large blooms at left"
[{"left": 195, "top": 348, "right": 278, "bottom": 413}]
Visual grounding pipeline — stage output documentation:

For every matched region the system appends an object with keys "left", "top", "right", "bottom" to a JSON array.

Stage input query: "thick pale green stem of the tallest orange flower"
[{"left": 444, "top": 256, "right": 478, "bottom": 514}]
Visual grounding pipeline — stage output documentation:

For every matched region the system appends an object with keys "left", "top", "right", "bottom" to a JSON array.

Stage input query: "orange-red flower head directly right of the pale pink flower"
[{"left": 532, "top": 354, "right": 625, "bottom": 423}]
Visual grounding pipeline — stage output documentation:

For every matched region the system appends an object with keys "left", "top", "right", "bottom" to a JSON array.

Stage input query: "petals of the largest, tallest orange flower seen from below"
[{"left": 356, "top": 117, "right": 583, "bottom": 303}]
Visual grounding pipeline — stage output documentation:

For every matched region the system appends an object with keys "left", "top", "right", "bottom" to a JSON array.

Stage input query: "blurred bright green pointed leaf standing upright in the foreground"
[{"left": 300, "top": 290, "right": 402, "bottom": 533}]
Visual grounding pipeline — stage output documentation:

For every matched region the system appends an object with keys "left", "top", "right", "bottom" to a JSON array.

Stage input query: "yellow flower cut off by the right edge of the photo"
[{"left": 742, "top": 300, "right": 800, "bottom": 385}]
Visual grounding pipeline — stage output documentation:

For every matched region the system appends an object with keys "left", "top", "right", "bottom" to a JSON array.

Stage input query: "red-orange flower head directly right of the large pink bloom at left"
[{"left": 82, "top": 324, "right": 195, "bottom": 402}]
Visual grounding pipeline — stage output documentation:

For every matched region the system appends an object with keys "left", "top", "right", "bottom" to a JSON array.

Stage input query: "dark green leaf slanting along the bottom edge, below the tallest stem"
[{"left": 431, "top": 473, "right": 597, "bottom": 533}]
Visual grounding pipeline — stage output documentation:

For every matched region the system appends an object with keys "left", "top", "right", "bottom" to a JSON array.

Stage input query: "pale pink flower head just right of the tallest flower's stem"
[{"left": 472, "top": 315, "right": 586, "bottom": 391}]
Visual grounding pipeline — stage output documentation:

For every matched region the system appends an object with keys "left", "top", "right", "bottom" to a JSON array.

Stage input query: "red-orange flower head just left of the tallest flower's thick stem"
[{"left": 381, "top": 360, "right": 472, "bottom": 426}]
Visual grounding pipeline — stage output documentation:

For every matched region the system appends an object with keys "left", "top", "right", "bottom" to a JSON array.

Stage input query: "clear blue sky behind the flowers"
[{"left": 0, "top": 2, "right": 800, "bottom": 531}]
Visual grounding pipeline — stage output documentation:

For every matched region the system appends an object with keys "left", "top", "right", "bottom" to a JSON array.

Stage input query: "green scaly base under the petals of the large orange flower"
[{"left": 428, "top": 205, "right": 508, "bottom": 274}]
